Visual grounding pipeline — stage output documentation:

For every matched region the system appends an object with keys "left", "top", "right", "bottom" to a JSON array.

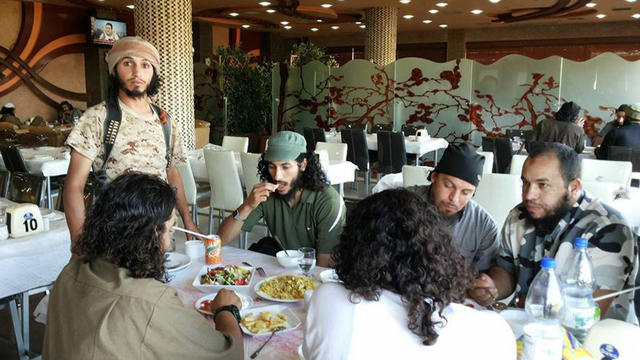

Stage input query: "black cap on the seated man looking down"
[{"left": 433, "top": 143, "right": 484, "bottom": 186}]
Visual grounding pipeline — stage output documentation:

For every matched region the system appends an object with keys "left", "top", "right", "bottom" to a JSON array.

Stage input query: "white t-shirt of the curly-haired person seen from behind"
[{"left": 303, "top": 283, "right": 517, "bottom": 360}]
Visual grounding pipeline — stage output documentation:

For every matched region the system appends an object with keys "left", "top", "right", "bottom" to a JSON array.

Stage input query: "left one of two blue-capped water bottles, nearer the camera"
[{"left": 522, "top": 258, "right": 564, "bottom": 360}]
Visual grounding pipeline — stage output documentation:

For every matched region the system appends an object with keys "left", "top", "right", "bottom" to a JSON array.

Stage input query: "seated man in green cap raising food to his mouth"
[{"left": 218, "top": 131, "right": 346, "bottom": 266}]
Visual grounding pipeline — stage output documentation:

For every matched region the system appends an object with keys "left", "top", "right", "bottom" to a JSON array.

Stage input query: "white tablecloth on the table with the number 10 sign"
[{"left": 0, "top": 199, "right": 71, "bottom": 298}]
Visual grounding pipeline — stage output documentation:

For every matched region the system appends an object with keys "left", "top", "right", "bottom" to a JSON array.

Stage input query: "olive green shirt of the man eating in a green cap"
[{"left": 242, "top": 186, "right": 346, "bottom": 254}]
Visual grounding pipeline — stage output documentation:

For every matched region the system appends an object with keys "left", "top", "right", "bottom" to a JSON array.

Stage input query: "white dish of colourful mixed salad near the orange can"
[{"left": 192, "top": 265, "right": 254, "bottom": 293}]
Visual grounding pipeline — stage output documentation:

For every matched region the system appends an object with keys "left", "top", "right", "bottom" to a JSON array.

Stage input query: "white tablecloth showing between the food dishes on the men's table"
[{"left": 169, "top": 246, "right": 325, "bottom": 360}]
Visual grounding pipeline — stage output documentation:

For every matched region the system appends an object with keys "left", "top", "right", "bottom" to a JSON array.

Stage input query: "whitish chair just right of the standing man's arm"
[{"left": 203, "top": 149, "right": 247, "bottom": 249}]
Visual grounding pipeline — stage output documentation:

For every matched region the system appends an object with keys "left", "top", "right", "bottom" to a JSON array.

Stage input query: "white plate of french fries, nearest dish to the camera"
[{"left": 240, "top": 305, "right": 301, "bottom": 336}]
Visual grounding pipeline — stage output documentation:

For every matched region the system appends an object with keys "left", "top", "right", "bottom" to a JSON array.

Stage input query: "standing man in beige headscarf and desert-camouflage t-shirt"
[{"left": 63, "top": 36, "right": 198, "bottom": 248}]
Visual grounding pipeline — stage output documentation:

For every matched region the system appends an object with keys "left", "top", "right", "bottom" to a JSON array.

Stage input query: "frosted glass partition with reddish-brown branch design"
[{"left": 272, "top": 53, "right": 640, "bottom": 146}]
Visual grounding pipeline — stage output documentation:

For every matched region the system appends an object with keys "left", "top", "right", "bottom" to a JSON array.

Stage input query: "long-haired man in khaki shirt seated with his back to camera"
[{"left": 43, "top": 173, "right": 243, "bottom": 360}]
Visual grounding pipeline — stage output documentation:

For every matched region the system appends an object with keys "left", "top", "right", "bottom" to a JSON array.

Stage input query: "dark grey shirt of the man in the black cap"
[{"left": 409, "top": 186, "right": 500, "bottom": 272}]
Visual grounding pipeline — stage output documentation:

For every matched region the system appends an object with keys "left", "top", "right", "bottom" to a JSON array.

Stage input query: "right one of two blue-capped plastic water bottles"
[{"left": 558, "top": 238, "right": 600, "bottom": 343}]
